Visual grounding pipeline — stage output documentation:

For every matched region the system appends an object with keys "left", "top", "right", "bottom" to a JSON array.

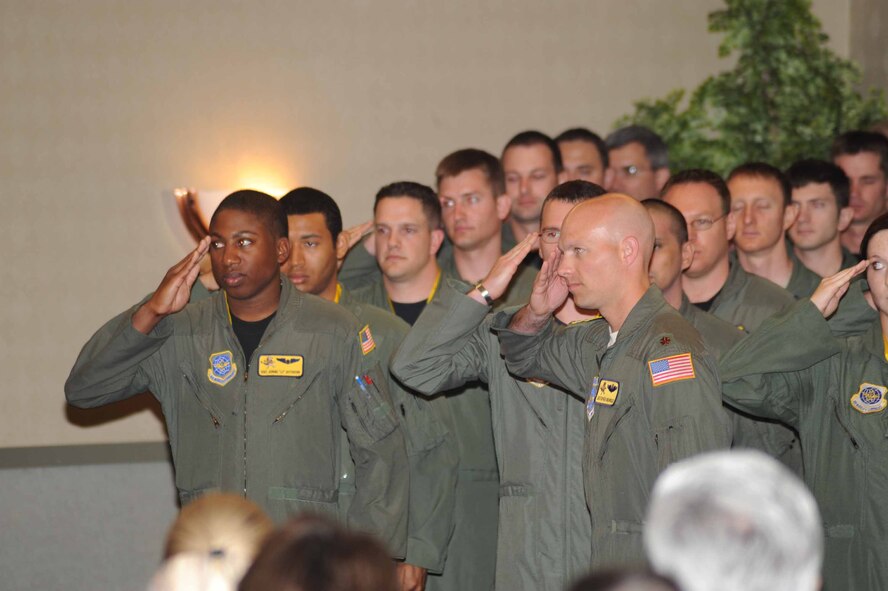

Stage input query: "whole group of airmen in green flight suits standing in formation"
[{"left": 65, "top": 126, "right": 888, "bottom": 591}]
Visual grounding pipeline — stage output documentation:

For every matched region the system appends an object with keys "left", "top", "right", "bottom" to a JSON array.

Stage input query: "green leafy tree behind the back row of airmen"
[{"left": 617, "top": 0, "right": 888, "bottom": 174}]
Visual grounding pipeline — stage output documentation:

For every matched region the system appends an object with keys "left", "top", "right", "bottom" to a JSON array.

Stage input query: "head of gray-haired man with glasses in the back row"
[{"left": 605, "top": 125, "right": 669, "bottom": 201}]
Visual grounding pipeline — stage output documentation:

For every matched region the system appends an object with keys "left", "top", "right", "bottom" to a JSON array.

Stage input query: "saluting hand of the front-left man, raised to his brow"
[{"left": 133, "top": 236, "right": 210, "bottom": 334}]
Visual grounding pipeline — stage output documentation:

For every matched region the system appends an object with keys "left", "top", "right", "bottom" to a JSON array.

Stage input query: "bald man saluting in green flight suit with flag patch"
[{"left": 493, "top": 194, "right": 730, "bottom": 568}]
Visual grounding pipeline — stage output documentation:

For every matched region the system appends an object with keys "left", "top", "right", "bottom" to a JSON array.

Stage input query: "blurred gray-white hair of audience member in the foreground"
[{"left": 644, "top": 450, "right": 823, "bottom": 591}]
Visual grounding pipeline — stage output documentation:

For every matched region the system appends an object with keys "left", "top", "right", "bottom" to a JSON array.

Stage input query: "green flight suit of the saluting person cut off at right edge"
[{"left": 720, "top": 300, "right": 888, "bottom": 591}]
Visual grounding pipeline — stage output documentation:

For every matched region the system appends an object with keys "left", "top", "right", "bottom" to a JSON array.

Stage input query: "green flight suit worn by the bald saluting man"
[{"left": 493, "top": 286, "right": 730, "bottom": 569}]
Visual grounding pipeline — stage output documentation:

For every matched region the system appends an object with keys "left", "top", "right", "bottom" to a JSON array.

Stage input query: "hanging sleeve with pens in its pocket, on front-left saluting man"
[{"left": 338, "top": 332, "right": 409, "bottom": 558}]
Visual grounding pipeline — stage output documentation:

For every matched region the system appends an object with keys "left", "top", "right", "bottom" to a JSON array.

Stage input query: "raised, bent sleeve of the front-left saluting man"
[{"left": 65, "top": 305, "right": 173, "bottom": 408}]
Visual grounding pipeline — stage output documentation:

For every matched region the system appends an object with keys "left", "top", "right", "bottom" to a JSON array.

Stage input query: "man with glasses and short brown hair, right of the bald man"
[{"left": 661, "top": 169, "right": 802, "bottom": 474}]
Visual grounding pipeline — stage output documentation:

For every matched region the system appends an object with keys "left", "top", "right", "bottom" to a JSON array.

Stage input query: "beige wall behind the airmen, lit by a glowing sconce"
[{"left": 0, "top": 0, "right": 849, "bottom": 447}]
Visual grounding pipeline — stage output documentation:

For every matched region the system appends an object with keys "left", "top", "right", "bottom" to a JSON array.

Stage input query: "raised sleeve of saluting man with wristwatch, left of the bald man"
[{"left": 392, "top": 281, "right": 489, "bottom": 396}]
